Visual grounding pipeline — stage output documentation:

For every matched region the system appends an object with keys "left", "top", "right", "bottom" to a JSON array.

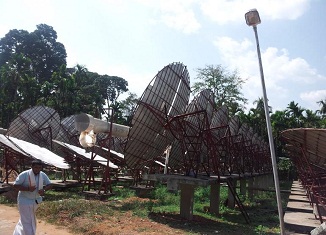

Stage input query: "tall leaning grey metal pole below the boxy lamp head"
[{"left": 253, "top": 25, "right": 285, "bottom": 235}]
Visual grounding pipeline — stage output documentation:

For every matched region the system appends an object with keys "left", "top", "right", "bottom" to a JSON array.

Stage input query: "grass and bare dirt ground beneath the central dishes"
[{"left": 0, "top": 179, "right": 291, "bottom": 235}]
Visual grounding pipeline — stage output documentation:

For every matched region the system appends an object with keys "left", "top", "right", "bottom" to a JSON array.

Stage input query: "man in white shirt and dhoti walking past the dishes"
[{"left": 13, "top": 160, "right": 51, "bottom": 235}]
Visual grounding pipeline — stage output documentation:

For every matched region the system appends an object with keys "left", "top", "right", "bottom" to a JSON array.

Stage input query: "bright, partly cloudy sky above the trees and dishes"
[{"left": 0, "top": 0, "right": 326, "bottom": 111}]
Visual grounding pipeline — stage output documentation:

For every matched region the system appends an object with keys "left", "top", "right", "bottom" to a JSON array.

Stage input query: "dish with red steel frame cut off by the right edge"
[{"left": 281, "top": 128, "right": 326, "bottom": 223}]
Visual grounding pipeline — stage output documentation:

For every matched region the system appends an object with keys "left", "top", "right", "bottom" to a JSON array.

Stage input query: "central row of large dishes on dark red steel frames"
[{"left": 124, "top": 63, "right": 272, "bottom": 181}]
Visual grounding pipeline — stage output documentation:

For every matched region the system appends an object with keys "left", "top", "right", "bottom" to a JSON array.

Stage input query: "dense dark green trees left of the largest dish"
[{"left": 0, "top": 24, "right": 133, "bottom": 128}]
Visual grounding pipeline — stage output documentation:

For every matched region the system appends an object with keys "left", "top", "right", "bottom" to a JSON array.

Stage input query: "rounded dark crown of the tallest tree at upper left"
[{"left": 0, "top": 24, "right": 67, "bottom": 84}]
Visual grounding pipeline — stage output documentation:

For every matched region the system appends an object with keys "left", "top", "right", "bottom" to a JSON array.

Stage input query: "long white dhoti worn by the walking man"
[{"left": 13, "top": 203, "right": 38, "bottom": 235}]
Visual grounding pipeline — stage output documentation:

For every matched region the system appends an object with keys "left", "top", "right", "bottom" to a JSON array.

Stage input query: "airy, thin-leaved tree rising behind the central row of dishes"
[{"left": 192, "top": 65, "right": 247, "bottom": 115}]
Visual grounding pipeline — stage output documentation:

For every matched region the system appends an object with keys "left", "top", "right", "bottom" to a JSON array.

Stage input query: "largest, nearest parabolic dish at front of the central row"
[{"left": 124, "top": 63, "right": 190, "bottom": 169}]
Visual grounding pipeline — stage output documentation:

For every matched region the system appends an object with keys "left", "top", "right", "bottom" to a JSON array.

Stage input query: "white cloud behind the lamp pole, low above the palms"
[{"left": 213, "top": 37, "right": 326, "bottom": 110}]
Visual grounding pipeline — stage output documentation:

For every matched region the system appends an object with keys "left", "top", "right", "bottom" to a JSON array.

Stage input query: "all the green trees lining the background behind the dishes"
[{"left": 0, "top": 24, "right": 326, "bottom": 164}]
